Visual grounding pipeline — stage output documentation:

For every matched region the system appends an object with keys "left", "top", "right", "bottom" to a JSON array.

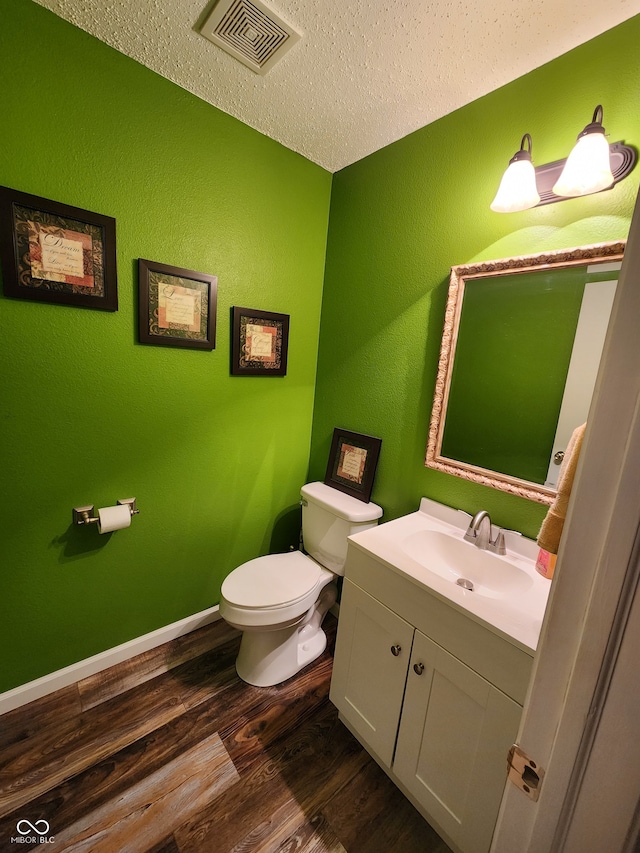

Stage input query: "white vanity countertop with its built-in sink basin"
[{"left": 346, "top": 498, "right": 551, "bottom": 652}]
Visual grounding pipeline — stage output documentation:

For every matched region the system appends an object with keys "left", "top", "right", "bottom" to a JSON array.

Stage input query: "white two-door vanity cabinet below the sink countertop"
[{"left": 330, "top": 543, "right": 533, "bottom": 853}]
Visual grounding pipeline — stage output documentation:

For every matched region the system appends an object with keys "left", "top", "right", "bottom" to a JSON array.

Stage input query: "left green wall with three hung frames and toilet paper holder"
[{"left": 0, "top": 0, "right": 331, "bottom": 690}]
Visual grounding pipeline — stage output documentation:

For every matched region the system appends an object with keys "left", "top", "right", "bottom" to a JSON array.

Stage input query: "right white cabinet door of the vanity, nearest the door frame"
[{"left": 393, "top": 631, "right": 522, "bottom": 853}]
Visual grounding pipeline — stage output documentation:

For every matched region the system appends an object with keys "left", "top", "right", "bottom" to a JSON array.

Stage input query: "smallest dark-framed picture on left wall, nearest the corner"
[{"left": 231, "top": 307, "right": 289, "bottom": 376}]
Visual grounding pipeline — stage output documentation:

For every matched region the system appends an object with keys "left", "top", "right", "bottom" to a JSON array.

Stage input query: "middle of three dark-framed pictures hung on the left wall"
[{"left": 138, "top": 258, "right": 218, "bottom": 350}]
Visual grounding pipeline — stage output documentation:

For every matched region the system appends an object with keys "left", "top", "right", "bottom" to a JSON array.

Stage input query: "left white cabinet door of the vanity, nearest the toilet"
[{"left": 329, "top": 579, "right": 414, "bottom": 767}]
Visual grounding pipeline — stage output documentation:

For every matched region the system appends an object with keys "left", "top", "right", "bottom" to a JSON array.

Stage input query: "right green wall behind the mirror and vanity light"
[{"left": 310, "top": 17, "right": 640, "bottom": 536}]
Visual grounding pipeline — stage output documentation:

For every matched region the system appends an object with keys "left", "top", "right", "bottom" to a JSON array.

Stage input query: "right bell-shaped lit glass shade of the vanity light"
[{"left": 553, "top": 104, "right": 614, "bottom": 198}]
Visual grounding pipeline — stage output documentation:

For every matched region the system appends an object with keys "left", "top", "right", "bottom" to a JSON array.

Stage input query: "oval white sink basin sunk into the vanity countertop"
[{"left": 402, "top": 530, "right": 533, "bottom": 598}]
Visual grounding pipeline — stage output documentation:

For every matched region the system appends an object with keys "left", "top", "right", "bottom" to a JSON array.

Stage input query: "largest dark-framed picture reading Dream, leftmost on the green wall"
[{"left": 0, "top": 187, "right": 118, "bottom": 311}]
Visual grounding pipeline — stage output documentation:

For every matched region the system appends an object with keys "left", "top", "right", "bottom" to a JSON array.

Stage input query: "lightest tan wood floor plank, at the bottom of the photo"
[{"left": 50, "top": 734, "right": 239, "bottom": 853}]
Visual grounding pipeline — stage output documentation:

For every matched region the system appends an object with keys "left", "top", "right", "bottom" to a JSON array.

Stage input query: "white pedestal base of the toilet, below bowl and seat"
[{"left": 236, "top": 583, "right": 337, "bottom": 687}]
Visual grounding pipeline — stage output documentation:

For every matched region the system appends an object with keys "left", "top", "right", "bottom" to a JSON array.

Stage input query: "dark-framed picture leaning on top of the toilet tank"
[{"left": 324, "top": 428, "right": 382, "bottom": 503}]
